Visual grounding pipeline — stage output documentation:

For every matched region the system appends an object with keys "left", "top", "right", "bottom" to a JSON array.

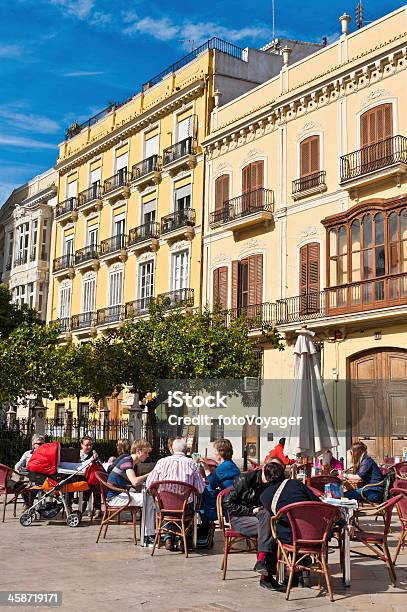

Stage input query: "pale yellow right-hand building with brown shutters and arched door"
[{"left": 202, "top": 7, "right": 407, "bottom": 459}]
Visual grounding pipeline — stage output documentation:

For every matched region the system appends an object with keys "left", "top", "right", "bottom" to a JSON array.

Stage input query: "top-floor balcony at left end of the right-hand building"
[{"left": 210, "top": 188, "right": 274, "bottom": 232}]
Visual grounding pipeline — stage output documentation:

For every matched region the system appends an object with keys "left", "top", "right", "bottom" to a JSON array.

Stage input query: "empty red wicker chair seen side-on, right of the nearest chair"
[{"left": 351, "top": 495, "right": 403, "bottom": 586}]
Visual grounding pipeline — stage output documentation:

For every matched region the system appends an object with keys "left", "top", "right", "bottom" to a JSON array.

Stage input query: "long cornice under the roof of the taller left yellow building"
[{"left": 55, "top": 79, "right": 205, "bottom": 175}]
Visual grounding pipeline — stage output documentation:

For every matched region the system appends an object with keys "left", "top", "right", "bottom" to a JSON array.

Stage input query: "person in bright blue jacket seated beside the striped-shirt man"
[{"left": 200, "top": 438, "right": 240, "bottom": 524}]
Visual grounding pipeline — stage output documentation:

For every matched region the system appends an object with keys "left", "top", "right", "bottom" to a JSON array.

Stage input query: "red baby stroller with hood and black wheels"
[{"left": 20, "top": 442, "right": 99, "bottom": 527}]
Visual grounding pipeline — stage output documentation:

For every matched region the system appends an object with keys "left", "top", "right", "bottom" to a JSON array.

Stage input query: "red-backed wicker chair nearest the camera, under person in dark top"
[{"left": 271, "top": 501, "right": 341, "bottom": 601}]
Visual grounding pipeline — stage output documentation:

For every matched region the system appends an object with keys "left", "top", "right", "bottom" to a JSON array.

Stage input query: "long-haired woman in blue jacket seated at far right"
[{"left": 345, "top": 442, "right": 384, "bottom": 503}]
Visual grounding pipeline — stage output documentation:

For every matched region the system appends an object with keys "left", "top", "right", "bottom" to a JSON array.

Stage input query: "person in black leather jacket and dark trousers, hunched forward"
[{"left": 225, "top": 458, "right": 284, "bottom": 590}]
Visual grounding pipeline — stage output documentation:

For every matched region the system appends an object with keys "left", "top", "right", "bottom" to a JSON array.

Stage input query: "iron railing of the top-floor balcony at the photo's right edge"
[{"left": 341, "top": 136, "right": 407, "bottom": 182}]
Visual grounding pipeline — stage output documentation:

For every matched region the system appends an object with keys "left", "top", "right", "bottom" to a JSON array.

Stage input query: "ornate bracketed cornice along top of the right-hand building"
[{"left": 203, "top": 32, "right": 407, "bottom": 159}]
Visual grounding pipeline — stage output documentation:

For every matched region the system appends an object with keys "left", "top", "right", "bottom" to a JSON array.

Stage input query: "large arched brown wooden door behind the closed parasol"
[{"left": 349, "top": 348, "right": 407, "bottom": 461}]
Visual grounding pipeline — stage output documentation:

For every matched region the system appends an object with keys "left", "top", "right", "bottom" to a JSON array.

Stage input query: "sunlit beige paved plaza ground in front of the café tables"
[{"left": 0, "top": 512, "right": 407, "bottom": 612}]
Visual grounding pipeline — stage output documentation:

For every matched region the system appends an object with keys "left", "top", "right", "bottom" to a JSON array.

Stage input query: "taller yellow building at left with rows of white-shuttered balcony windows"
[{"left": 47, "top": 39, "right": 298, "bottom": 417}]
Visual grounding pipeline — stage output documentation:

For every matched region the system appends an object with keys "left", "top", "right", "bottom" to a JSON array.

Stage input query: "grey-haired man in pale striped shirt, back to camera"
[{"left": 146, "top": 438, "right": 205, "bottom": 550}]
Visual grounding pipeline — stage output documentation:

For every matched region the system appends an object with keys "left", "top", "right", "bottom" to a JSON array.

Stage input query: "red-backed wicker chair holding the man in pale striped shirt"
[{"left": 149, "top": 480, "right": 201, "bottom": 557}]
